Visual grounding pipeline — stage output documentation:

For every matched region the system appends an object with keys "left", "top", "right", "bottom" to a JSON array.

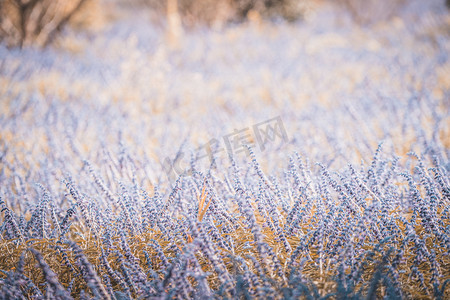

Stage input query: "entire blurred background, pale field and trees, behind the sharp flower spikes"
[{"left": 0, "top": 0, "right": 450, "bottom": 186}]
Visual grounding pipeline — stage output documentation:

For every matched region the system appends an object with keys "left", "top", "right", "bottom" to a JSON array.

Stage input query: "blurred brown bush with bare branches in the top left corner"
[{"left": 0, "top": 0, "right": 92, "bottom": 47}]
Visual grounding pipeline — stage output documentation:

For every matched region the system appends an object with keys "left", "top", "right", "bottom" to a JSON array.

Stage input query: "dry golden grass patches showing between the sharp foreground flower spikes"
[{"left": 0, "top": 197, "right": 450, "bottom": 299}]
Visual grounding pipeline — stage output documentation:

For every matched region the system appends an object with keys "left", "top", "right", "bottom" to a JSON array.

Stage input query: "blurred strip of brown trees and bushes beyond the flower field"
[{"left": 0, "top": 0, "right": 450, "bottom": 47}]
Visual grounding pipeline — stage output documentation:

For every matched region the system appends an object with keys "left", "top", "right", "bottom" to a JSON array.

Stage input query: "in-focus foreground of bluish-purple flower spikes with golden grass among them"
[{"left": 0, "top": 146, "right": 450, "bottom": 299}]
